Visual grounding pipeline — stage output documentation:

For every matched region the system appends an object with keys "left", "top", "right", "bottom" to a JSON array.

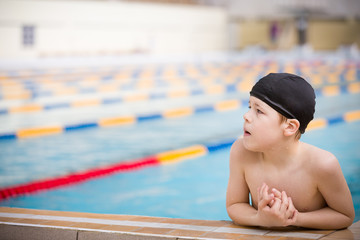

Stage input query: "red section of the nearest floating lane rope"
[{"left": 0, "top": 156, "right": 160, "bottom": 201}]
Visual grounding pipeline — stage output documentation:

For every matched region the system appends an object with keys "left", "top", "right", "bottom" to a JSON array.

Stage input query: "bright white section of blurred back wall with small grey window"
[{"left": 0, "top": 0, "right": 227, "bottom": 58}]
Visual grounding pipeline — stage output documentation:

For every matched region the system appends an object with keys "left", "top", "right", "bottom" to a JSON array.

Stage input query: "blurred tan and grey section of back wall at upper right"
[{"left": 227, "top": 0, "right": 360, "bottom": 50}]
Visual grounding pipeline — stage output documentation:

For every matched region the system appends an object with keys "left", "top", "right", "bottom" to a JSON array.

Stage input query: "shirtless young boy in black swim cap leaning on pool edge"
[{"left": 226, "top": 73, "right": 355, "bottom": 229}]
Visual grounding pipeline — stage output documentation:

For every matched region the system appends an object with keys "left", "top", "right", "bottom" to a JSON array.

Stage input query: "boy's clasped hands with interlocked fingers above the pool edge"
[{"left": 257, "top": 183, "right": 298, "bottom": 227}]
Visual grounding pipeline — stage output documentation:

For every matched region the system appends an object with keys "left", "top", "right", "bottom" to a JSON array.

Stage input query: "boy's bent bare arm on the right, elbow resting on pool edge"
[{"left": 295, "top": 156, "right": 355, "bottom": 229}]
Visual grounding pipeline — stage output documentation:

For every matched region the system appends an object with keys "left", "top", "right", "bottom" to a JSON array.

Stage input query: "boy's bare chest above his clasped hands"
[{"left": 245, "top": 165, "right": 325, "bottom": 212}]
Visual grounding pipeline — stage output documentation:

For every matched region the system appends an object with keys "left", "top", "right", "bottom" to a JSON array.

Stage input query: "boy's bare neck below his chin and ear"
[{"left": 261, "top": 140, "right": 301, "bottom": 167}]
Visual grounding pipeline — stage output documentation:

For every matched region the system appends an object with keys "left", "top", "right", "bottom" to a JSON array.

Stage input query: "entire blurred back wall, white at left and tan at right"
[{"left": 0, "top": 0, "right": 360, "bottom": 58}]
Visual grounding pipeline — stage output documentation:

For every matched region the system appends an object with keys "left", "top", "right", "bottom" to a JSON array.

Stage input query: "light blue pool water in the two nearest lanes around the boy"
[{"left": 0, "top": 94, "right": 360, "bottom": 220}]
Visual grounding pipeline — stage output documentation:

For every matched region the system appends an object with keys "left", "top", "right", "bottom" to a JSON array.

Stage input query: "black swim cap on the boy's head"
[{"left": 250, "top": 73, "right": 315, "bottom": 133}]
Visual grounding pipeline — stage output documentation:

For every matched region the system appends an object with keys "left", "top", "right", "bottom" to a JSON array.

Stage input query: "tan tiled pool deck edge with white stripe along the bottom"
[{"left": 0, "top": 207, "right": 360, "bottom": 240}]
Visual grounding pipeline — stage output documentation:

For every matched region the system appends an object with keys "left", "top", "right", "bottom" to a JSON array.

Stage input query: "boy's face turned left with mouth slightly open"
[{"left": 243, "top": 96, "right": 284, "bottom": 152}]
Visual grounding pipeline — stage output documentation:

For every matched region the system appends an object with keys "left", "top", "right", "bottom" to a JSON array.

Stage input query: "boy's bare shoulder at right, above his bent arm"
[{"left": 304, "top": 143, "right": 341, "bottom": 175}]
